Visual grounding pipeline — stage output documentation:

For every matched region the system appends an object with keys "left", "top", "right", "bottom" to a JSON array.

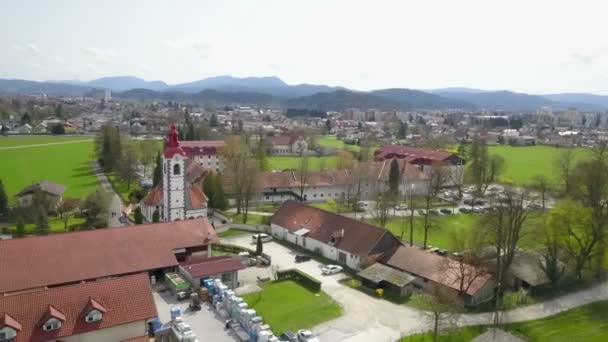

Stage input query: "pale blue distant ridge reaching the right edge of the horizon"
[{"left": 441, "top": 91, "right": 604, "bottom": 111}]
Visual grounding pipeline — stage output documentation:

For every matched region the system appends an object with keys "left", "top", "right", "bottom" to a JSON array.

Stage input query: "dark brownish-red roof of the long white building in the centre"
[{"left": 271, "top": 201, "right": 401, "bottom": 256}]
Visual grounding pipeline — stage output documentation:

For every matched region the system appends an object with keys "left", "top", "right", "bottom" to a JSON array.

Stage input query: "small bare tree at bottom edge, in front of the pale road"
[{"left": 422, "top": 286, "right": 462, "bottom": 341}]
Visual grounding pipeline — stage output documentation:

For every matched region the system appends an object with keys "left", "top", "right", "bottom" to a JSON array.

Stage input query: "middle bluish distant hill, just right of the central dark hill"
[{"left": 371, "top": 88, "right": 475, "bottom": 109}]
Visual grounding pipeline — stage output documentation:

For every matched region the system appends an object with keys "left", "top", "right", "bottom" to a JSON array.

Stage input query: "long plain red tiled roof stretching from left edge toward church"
[{"left": 0, "top": 218, "right": 219, "bottom": 293}]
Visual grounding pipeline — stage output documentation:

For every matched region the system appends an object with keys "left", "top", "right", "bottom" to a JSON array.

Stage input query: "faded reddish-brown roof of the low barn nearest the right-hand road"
[{"left": 382, "top": 246, "right": 492, "bottom": 296}]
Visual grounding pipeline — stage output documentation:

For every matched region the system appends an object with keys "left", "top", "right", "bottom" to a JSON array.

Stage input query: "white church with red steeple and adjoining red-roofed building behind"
[{"left": 140, "top": 124, "right": 223, "bottom": 222}]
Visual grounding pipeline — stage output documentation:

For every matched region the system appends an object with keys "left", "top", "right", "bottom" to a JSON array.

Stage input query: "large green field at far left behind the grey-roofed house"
[{"left": 0, "top": 136, "right": 98, "bottom": 204}]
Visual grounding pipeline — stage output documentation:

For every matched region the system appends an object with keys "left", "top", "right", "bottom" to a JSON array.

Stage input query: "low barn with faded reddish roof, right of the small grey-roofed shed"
[{"left": 379, "top": 246, "right": 494, "bottom": 306}]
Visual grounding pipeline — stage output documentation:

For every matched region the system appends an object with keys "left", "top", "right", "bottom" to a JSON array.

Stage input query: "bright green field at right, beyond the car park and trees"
[{"left": 488, "top": 146, "right": 591, "bottom": 185}]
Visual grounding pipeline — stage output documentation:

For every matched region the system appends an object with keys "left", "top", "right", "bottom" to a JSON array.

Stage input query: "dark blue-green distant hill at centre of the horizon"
[{"left": 286, "top": 90, "right": 412, "bottom": 111}]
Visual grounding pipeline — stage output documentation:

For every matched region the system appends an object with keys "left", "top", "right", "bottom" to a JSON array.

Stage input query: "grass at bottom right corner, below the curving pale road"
[{"left": 400, "top": 301, "right": 608, "bottom": 342}]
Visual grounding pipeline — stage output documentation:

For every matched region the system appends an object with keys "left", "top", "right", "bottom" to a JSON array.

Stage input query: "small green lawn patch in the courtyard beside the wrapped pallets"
[{"left": 243, "top": 281, "right": 342, "bottom": 333}]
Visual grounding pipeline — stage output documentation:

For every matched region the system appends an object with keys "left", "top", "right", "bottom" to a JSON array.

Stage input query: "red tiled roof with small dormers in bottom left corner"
[{"left": 0, "top": 274, "right": 158, "bottom": 342}]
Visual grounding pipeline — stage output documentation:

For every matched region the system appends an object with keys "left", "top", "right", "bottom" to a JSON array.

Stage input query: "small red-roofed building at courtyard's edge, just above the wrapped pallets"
[{"left": 179, "top": 255, "right": 245, "bottom": 289}]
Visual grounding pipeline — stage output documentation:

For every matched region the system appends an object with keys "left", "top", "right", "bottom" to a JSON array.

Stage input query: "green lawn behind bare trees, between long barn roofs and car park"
[{"left": 372, "top": 212, "right": 542, "bottom": 250}]
